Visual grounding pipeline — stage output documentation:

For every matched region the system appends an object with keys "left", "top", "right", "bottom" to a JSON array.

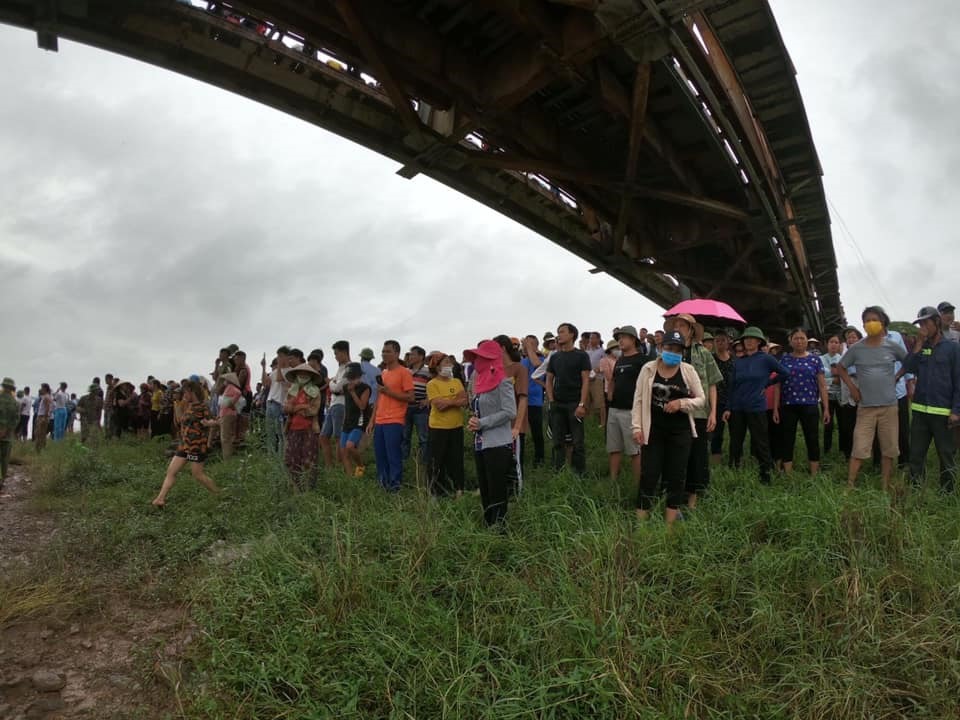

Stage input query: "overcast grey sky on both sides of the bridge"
[{"left": 0, "top": 0, "right": 960, "bottom": 390}]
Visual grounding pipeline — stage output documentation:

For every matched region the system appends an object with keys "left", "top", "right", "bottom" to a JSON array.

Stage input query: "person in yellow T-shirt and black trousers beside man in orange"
[{"left": 427, "top": 355, "right": 467, "bottom": 498}]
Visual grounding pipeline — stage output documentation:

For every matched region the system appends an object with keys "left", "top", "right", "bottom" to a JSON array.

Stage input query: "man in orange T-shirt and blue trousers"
[{"left": 367, "top": 340, "right": 413, "bottom": 492}]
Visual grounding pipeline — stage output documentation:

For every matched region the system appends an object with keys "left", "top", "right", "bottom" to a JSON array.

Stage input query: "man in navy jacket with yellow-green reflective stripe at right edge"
[{"left": 904, "top": 307, "right": 960, "bottom": 493}]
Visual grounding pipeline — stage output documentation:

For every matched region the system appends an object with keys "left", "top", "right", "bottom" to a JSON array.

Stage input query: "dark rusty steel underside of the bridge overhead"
[{"left": 0, "top": 0, "right": 844, "bottom": 332}]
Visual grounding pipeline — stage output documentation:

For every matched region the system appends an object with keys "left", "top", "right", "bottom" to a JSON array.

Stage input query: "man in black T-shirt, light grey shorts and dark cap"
[{"left": 607, "top": 325, "right": 648, "bottom": 484}]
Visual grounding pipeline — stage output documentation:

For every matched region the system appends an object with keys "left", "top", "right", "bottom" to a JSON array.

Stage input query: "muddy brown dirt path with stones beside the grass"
[{"left": 0, "top": 466, "right": 194, "bottom": 720}]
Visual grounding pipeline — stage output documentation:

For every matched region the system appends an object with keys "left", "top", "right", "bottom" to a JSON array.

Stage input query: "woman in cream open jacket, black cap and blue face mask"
[{"left": 631, "top": 330, "right": 706, "bottom": 523}]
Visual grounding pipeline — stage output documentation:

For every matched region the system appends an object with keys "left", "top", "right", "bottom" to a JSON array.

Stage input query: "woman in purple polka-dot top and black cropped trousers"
[{"left": 773, "top": 328, "right": 830, "bottom": 475}]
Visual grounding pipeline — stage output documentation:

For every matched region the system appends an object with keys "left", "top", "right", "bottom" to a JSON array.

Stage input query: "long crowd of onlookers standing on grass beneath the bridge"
[{"left": 0, "top": 302, "right": 960, "bottom": 526}]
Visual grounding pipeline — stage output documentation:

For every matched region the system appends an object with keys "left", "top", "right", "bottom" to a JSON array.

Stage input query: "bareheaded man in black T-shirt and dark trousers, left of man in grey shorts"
[{"left": 546, "top": 323, "right": 603, "bottom": 476}]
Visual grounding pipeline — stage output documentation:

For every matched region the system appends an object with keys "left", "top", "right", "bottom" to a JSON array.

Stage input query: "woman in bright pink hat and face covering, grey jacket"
[{"left": 464, "top": 340, "right": 517, "bottom": 526}]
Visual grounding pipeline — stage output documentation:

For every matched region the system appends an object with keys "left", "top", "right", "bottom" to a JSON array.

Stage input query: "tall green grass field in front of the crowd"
[{"left": 11, "top": 430, "right": 960, "bottom": 719}]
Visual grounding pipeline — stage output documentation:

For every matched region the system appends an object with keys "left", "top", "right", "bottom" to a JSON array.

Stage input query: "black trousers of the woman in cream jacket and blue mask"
[{"left": 637, "top": 423, "right": 693, "bottom": 510}]
